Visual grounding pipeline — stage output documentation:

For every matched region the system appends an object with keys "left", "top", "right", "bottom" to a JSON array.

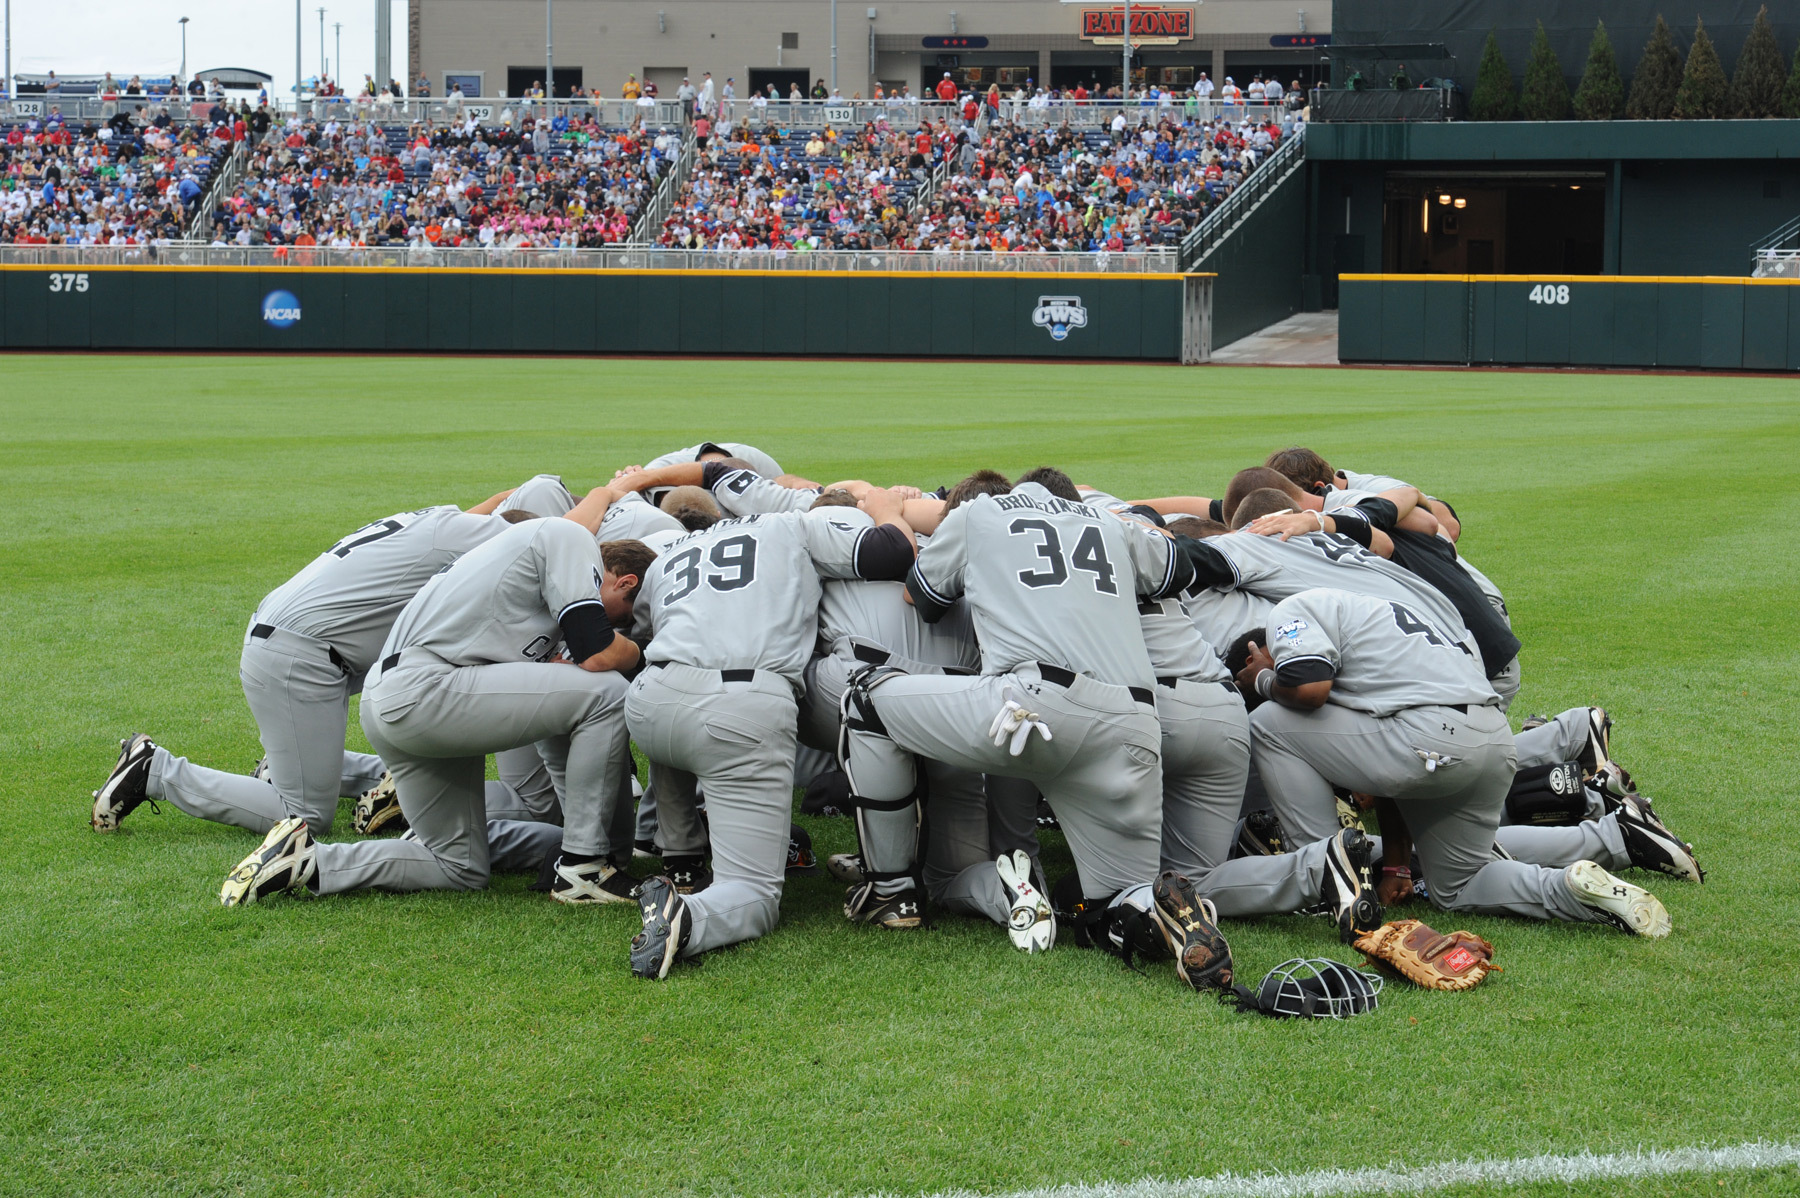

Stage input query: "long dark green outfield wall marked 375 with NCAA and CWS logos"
[{"left": 0, "top": 266, "right": 1211, "bottom": 362}]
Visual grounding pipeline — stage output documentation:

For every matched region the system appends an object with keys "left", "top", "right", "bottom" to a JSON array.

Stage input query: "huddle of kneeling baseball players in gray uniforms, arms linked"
[{"left": 92, "top": 443, "right": 1703, "bottom": 989}]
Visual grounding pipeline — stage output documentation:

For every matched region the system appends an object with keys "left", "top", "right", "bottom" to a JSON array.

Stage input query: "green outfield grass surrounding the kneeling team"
[{"left": 0, "top": 356, "right": 1800, "bottom": 1194}]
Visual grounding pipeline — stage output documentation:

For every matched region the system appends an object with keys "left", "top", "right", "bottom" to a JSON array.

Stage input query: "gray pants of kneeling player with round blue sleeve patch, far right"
[{"left": 1251, "top": 702, "right": 1598, "bottom": 921}]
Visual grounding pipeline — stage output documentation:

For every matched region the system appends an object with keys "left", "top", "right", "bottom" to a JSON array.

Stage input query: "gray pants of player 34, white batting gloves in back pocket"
[{"left": 850, "top": 666, "right": 1163, "bottom": 906}]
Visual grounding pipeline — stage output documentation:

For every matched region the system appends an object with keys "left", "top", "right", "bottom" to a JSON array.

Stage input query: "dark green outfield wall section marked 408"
[{"left": 1337, "top": 275, "right": 1800, "bottom": 371}]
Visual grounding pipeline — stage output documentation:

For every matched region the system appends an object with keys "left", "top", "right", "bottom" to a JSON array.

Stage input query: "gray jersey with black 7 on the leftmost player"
[{"left": 256, "top": 505, "right": 515, "bottom": 675}]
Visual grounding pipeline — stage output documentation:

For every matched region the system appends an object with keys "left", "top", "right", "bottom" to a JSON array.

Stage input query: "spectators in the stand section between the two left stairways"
[{"left": 212, "top": 115, "right": 680, "bottom": 248}]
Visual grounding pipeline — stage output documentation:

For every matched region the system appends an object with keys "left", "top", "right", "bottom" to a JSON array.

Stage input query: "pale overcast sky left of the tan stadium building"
[{"left": 11, "top": 0, "right": 407, "bottom": 90}]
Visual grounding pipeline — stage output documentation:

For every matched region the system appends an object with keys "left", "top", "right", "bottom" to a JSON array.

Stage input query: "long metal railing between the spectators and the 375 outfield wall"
[{"left": 0, "top": 241, "right": 1179, "bottom": 275}]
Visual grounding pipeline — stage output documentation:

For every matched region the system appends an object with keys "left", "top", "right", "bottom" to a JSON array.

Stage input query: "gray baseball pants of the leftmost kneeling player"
[{"left": 148, "top": 628, "right": 382, "bottom": 836}]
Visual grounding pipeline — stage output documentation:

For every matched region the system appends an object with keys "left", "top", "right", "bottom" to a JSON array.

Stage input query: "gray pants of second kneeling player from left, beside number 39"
[{"left": 317, "top": 655, "right": 625, "bottom": 894}]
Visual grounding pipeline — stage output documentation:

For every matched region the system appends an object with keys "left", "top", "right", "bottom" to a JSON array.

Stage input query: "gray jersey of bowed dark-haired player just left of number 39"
[{"left": 382, "top": 516, "right": 601, "bottom": 666}]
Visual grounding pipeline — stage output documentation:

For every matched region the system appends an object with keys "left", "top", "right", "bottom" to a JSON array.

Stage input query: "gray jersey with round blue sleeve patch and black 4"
[{"left": 1265, "top": 588, "right": 1499, "bottom": 718}]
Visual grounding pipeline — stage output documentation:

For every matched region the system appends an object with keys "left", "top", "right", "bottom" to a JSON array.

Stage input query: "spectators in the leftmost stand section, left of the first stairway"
[{"left": 0, "top": 106, "right": 232, "bottom": 245}]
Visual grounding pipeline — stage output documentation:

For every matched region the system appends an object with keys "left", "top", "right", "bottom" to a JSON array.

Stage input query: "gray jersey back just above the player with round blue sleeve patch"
[{"left": 1201, "top": 531, "right": 1471, "bottom": 642}]
